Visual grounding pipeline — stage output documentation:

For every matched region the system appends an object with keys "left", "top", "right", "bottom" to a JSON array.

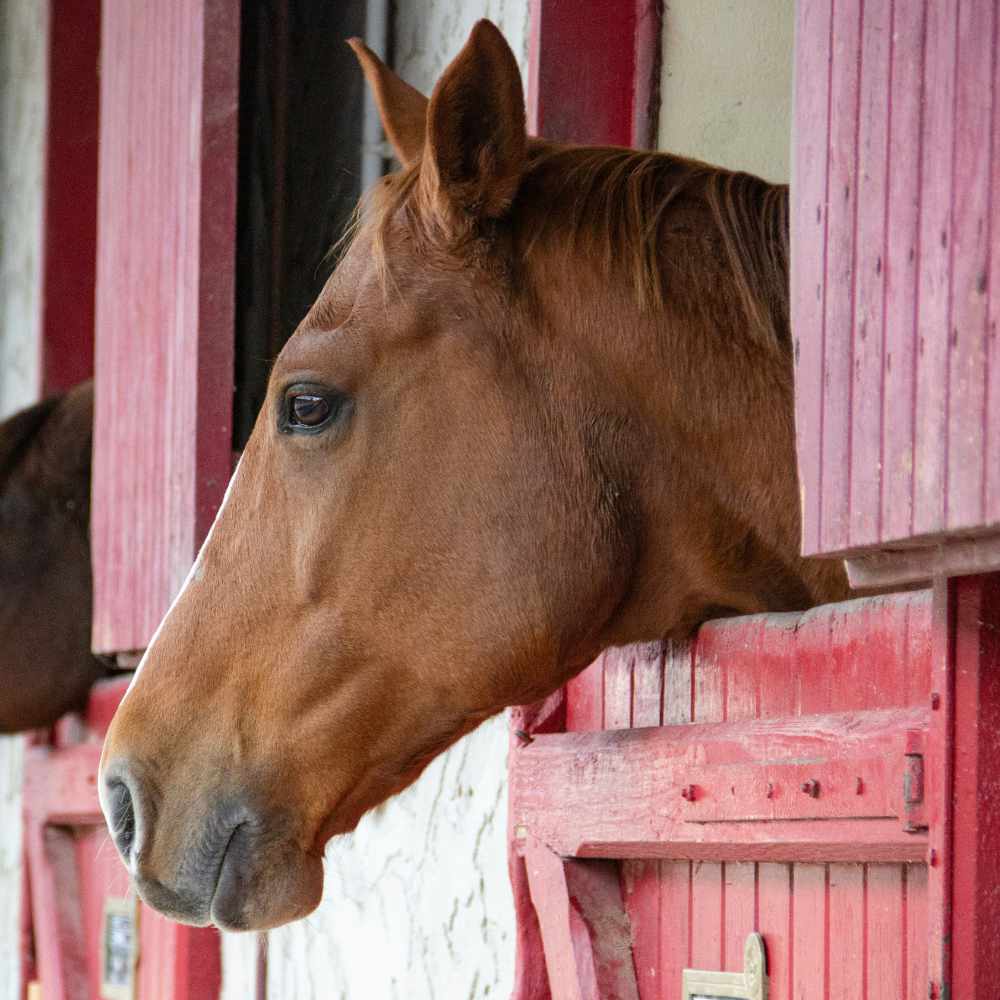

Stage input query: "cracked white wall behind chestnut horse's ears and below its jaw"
[{"left": 252, "top": 0, "right": 528, "bottom": 1000}]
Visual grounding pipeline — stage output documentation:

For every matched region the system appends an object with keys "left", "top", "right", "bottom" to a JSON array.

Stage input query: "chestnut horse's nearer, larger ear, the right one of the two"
[{"left": 421, "top": 21, "right": 528, "bottom": 224}]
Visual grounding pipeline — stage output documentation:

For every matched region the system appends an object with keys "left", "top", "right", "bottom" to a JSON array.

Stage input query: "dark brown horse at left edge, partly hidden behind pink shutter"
[{"left": 0, "top": 382, "right": 106, "bottom": 733}]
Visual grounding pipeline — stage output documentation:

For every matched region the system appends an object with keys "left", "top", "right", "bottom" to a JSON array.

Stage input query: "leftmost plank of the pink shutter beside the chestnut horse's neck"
[{"left": 790, "top": 0, "right": 833, "bottom": 553}]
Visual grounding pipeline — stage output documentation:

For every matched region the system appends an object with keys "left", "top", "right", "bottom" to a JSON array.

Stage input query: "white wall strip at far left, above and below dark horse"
[{"left": 0, "top": 0, "right": 48, "bottom": 1000}]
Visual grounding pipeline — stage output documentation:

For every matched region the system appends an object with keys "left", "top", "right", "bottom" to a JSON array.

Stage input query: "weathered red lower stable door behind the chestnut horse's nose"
[{"left": 24, "top": 678, "right": 221, "bottom": 1000}]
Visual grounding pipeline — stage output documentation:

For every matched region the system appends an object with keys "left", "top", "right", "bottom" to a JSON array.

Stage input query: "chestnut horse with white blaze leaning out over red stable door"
[{"left": 101, "top": 22, "right": 847, "bottom": 928}]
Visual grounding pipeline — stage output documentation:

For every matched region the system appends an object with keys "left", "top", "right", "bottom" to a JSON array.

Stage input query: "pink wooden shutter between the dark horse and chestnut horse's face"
[{"left": 91, "top": 0, "right": 239, "bottom": 652}]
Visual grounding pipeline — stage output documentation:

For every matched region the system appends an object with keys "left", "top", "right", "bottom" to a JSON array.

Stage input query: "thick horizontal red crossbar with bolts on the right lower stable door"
[{"left": 511, "top": 708, "right": 929, "bottom": 860}]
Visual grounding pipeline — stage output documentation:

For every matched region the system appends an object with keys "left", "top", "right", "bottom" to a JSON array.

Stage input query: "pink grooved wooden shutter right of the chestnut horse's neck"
[{"left": 792, "top": 0, "right": 1000, "bottom": 568}]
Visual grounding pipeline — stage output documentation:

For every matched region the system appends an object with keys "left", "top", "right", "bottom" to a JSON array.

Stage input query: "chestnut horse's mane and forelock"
[{"left": 358, "top": 140, "right": 790, "bottom": 347}]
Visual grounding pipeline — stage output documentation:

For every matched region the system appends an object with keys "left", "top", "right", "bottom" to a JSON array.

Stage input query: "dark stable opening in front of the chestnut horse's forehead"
[{"left": 233, "top": 0, "right": 378, "bottom": 450}]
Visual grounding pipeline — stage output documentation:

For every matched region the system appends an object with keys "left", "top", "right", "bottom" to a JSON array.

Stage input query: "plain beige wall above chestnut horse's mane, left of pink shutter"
[{"left": 659, "top": 0, "right": 795, "bottom": 182}]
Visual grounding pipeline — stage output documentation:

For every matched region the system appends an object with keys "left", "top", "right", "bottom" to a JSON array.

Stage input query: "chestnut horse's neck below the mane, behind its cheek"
[{"left": 528, "top": 230, "right": 847, "bottom": 640}]
